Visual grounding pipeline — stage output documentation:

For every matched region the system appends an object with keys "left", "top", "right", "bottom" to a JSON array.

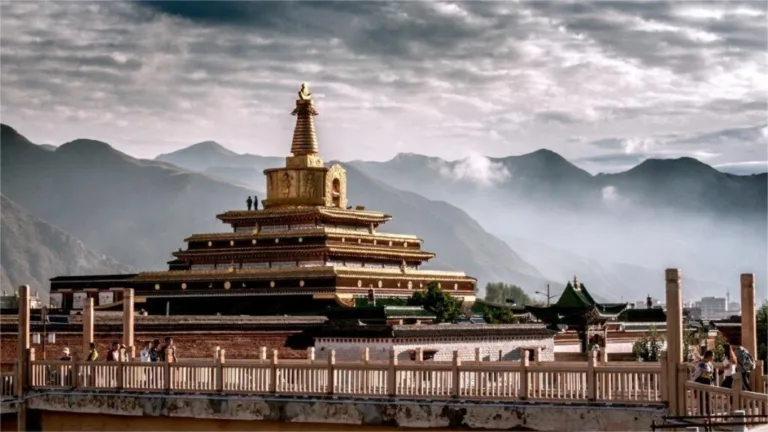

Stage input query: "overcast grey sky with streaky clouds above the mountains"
[{"left": 0, "top": 1, "right": 768, "bottom": 172}]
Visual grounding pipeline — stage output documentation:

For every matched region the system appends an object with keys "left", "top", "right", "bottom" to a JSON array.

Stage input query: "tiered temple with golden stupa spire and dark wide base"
[{"left": 46, "top": 85, "right": 477, "bottom": 315}]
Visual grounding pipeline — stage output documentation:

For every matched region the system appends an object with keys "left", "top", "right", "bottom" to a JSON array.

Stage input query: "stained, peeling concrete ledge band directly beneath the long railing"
[{"left": 28, "top": 391, "right": 667, "bottom": 431}]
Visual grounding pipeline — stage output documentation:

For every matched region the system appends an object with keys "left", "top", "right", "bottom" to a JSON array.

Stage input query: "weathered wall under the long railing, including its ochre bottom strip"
[{"left": 21, "top": 392, "right": 666, "bottom": 431}]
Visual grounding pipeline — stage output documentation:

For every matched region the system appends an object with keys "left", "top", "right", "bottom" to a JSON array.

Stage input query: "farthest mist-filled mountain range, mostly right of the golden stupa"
[{"left": 156, "top": 143, "right": 768, "bottom": 300}]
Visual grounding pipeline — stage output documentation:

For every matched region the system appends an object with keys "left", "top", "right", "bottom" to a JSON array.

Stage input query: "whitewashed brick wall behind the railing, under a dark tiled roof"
[{"left": 315, "top": 337, "right": 555, "bottom": 361}]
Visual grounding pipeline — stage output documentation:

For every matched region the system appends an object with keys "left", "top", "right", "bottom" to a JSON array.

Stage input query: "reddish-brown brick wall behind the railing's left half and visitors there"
[{"left": 0, "top": 331, "right": 307, "bottom": 364}]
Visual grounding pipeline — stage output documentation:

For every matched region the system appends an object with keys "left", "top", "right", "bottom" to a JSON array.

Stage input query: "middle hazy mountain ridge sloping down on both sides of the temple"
[{"left": 2, "top": 126, "right": 546, "bottom": 298}]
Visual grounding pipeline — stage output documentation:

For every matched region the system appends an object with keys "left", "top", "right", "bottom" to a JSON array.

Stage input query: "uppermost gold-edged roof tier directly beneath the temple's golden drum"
[{"left": 216, "top": 206, "right": 392, "bottom": 223}]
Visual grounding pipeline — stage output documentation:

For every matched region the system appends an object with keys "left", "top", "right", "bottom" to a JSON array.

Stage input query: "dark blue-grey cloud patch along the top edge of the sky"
[{"left": 140, "top": 1, "right": 525, "bottom": 58}]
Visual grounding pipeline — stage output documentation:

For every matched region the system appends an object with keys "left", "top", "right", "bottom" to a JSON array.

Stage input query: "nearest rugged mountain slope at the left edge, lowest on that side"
[{"left": 0, "top": 196, "right": 133, "bottom": 300}]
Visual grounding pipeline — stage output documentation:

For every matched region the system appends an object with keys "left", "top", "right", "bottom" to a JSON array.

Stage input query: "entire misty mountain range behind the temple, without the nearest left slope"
[{"left": 1, "top": 121, "right": 768, "bottom": 301}]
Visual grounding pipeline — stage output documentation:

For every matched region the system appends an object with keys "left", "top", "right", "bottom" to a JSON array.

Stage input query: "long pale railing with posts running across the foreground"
[{"left": 30, "top": 350, "right": 665, "bottom": 404}]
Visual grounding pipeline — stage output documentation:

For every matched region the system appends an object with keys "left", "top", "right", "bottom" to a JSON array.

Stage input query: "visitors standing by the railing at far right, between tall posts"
[{"left": 693, "top": 344, "right": 756, "bottom": 391}]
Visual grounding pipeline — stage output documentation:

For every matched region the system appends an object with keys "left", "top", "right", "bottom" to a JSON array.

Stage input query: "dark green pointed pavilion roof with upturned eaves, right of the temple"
[{"left": 526, "top": 278, "right": 627, "bottom": 324}]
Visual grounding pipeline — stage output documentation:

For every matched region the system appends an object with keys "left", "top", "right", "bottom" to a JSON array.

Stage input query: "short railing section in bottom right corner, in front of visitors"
[{"left": 685, "top": 374, "right": 768, "bottom": 423}]
